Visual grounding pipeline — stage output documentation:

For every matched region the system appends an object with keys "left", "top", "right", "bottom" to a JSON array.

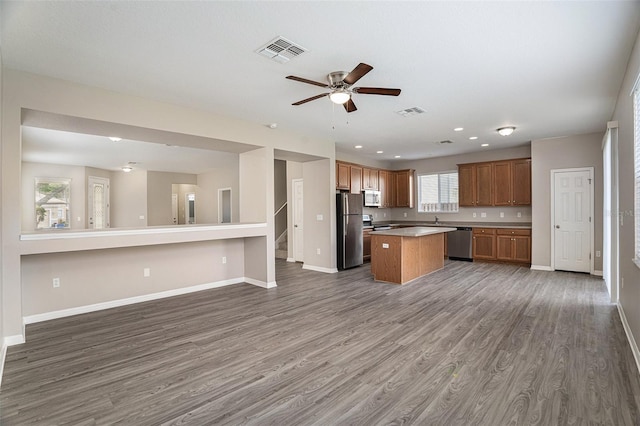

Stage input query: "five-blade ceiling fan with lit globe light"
[{"left": 287, "top": 63, "right": 400, "bottom": 112}]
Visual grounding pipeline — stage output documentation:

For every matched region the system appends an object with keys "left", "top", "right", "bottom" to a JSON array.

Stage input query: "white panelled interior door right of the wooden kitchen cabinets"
[{"left": 553, "top": 169, "right": 592, "bottom": 272}]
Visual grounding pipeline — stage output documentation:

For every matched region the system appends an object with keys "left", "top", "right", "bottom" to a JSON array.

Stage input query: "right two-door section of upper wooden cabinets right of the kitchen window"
[{"left": 493, "top": 158, "right": 531, "bottom": 206}]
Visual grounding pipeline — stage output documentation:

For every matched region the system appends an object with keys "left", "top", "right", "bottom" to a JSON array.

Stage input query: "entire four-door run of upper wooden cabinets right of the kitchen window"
[{"left": 458, "top": 158, "right": 531, "bottom": 207}]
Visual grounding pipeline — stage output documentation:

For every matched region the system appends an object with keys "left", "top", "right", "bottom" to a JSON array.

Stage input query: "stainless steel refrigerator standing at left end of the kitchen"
[{"left": 336, "top": 193, "right": 362, "bottom": 270}]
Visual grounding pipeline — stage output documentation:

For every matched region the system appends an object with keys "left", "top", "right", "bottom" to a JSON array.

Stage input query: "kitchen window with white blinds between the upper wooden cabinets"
[{"left": 418, "top": 172, "right": 458, "bottom": 213}]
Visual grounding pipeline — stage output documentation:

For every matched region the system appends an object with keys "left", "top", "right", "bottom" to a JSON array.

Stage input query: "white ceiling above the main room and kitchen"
[{"left": 5, "top": 1, "right": 640, "bottom": 160}]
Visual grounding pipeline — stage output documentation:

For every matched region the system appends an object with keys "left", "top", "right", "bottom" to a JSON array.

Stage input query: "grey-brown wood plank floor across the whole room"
[{"left": 0, "top": 261, "right": 640, "bottom": 426}]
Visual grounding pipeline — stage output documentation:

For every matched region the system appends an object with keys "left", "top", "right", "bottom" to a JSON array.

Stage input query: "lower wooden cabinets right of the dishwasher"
[{"left": 473, "top": 228, "right": 531, "bottom": 263}]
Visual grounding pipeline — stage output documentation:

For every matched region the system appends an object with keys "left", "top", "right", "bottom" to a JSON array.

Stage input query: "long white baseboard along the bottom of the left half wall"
[{"left": 22, "top": 277, "right": 247, "bottom": 324}]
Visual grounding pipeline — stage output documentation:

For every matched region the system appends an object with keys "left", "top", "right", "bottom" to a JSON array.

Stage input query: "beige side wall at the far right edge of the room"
[{"left": 603, "top": 29, "right": 640, "bottom": 359}]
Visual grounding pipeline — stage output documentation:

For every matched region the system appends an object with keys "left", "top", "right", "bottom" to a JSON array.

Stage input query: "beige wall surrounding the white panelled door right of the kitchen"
[{"left": 531, "top": 130, "right": 604, "bottom": 271}]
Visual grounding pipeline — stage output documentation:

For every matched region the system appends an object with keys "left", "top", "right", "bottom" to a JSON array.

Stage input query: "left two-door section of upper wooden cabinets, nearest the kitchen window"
[{"left": 458, "top": 163, "right": 493, "bottom": 207}]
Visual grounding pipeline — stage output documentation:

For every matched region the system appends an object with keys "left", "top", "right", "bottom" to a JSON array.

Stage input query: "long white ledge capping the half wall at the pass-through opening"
[{"left": 20, "top": 223, "right": 267, "bottom": 241}]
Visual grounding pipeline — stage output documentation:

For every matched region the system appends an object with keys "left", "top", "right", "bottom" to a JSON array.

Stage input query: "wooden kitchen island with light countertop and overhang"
[{"left": 371, "top": 226, "right": 456, "bottom": 284}]
